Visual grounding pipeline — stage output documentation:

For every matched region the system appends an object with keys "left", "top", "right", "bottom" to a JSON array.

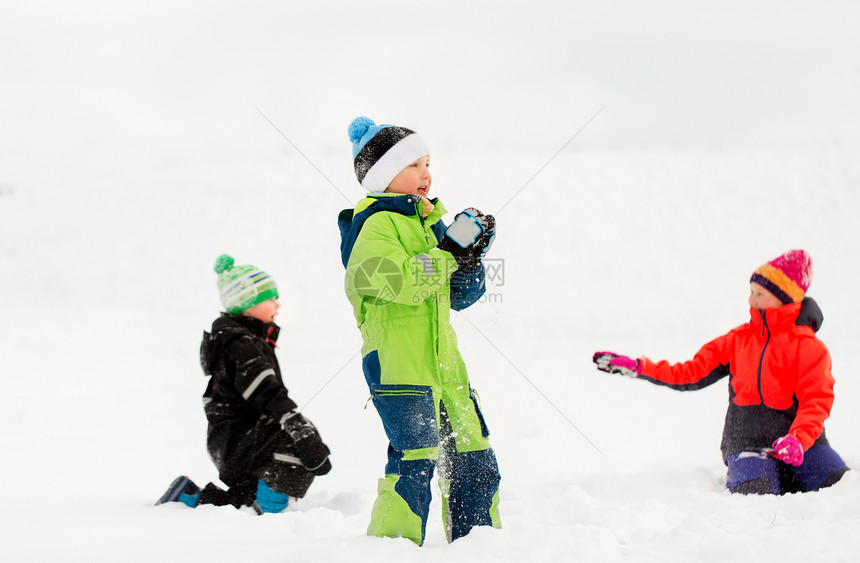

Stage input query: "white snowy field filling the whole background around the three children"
[{"left": 0, "top": 0, "right": 860, "bottom": 563}]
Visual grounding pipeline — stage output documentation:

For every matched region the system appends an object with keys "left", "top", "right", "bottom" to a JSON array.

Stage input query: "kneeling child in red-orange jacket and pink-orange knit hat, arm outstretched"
[{"left": 593, "top": 250, "right": 848, "bottom": 495}]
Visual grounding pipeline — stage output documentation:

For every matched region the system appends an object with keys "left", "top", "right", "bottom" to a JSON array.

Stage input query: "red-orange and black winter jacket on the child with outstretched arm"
[{"left": 639, "top": 299, "right": 834, "bottom": 459}]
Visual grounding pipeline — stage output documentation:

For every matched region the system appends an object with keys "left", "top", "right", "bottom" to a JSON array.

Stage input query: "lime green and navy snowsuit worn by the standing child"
[{"left": 338, "top": 194, "right": 501, "bottom": 545}]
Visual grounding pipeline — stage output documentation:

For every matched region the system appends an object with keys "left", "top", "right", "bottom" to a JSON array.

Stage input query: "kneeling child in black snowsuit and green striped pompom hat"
[{"left": 156, "top": 255, "right": 331, "bottom": 513}]
